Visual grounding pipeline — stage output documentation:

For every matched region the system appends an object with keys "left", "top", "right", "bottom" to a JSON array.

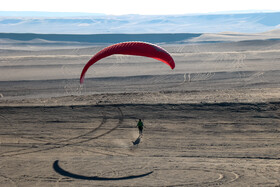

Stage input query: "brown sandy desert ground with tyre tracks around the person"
[{"left": 0, "top": 37, "right": 280, "bottom": 186}]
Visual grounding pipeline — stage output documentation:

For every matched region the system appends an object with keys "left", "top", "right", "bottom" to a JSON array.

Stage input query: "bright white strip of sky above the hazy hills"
[{"left": 0, "top": 0, "right": 280, "bottom": 15}]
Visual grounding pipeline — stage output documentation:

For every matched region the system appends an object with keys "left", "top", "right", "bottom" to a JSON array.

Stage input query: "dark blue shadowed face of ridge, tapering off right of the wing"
[{"left": 0, "top": 33, "right": 201, "bottom": 45}]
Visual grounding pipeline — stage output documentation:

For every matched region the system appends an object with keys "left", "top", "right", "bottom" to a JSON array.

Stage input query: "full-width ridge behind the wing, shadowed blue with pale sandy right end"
[{"left": 0, "top": 29, "right": 280, "bottom": 47}]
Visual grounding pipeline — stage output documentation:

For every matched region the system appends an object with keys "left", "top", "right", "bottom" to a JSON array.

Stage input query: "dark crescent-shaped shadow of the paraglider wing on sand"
[{"left": 53, "top": 160, "right": 153, "bottom": 181}]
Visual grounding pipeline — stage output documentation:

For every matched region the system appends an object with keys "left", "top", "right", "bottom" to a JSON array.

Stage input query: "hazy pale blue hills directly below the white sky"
[{"left": 0, "top": 11, "right": 280, "bottom": 34}]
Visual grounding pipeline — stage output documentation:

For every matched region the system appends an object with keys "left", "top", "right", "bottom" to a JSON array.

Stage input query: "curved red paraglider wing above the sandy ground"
[{"left": 80, "top": 42, "right": 175, "bottom": 83}]
